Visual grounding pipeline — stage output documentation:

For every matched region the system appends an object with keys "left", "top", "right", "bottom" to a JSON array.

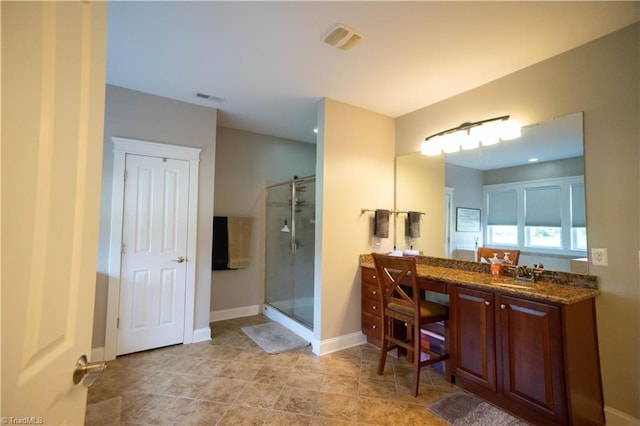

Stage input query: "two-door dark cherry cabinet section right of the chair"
[{"left": 450, "top": 286, "right": 604, "bottom": 425}]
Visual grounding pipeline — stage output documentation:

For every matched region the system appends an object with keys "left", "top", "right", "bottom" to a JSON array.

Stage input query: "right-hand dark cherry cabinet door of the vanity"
[{"left": 498, "top": 296, "right": 566, "bottom": 421}]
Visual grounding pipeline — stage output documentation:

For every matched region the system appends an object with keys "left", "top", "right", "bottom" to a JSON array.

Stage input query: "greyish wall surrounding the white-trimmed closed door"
[{"left": 93, "top": 85, "right": 217, "bottom": 348}]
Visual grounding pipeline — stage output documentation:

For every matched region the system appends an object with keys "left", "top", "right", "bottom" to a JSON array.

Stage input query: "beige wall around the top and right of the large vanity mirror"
[{"left": 396, "top": 24, "right": 640, "bottom": 419}]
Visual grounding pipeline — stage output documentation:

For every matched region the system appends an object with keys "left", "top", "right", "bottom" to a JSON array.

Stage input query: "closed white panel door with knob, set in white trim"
[{"left": 117, "top": 154, "right": 189, "bottom": 355}]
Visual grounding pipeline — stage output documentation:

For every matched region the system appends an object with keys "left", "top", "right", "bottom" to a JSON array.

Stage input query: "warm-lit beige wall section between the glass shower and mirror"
[{"left": 314, "top": 99, "right": 394, "bottom": 340}]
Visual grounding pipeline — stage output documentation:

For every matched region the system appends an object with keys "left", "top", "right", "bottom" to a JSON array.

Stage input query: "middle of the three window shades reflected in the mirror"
[{"left": 524, "top": 186, "right": 562, "bottom": 228}]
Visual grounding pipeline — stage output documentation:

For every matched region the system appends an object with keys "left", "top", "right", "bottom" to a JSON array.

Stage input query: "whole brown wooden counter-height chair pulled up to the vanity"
[{"left": 372, "top": 253, "right": 449, "bottom": 396}]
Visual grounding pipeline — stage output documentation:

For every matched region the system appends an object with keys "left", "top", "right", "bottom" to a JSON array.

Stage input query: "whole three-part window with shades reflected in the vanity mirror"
[{"left": 484, "top": 176, "right": 587, "bottom": 254}]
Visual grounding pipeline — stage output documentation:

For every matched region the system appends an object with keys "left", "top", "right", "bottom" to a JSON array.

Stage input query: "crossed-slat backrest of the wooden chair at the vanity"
[{"left": 371, "top": 253, "right": 420, "bottom": 315}]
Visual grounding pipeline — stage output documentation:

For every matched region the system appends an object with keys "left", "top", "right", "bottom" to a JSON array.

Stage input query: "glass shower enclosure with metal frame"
[{"left": 265, "top": 176, "right": 316, "bottom": 329}]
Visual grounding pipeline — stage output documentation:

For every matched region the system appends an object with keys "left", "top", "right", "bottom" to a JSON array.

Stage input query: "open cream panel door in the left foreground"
[{"left": 1, "top": 2, "right": 107, "bottom": 425}]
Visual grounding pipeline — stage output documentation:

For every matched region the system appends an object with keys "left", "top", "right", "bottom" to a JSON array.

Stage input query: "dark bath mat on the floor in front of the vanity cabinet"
[{"left": 429, "top": 392, "right": 528, "bottom": 426}]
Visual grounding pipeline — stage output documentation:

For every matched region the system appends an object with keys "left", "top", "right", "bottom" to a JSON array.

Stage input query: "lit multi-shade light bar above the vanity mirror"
[{"left": 422, "top": 115, "right": 521, "bottom": 155}]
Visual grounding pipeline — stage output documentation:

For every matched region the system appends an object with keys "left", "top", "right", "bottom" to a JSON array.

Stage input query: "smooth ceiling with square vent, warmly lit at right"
[{"left": 107, "top": 1, "right": 640, "bottom": 143}]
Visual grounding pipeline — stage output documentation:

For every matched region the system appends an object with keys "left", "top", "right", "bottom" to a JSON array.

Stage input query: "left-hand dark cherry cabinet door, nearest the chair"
[{"left": 449, "top": 286, "right": 496, "bottom": 392}]
